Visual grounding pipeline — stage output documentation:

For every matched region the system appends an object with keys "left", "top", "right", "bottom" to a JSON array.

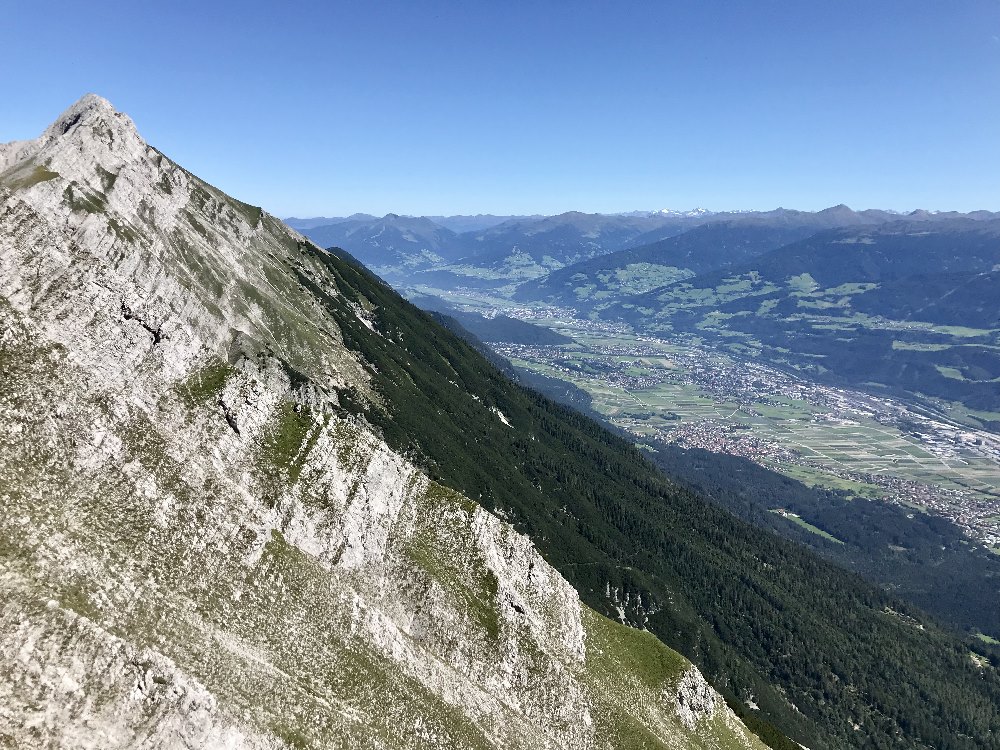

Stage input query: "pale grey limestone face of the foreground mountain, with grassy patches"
[{"left": 0, "top": 96, "right": 759, "bottom": 748}]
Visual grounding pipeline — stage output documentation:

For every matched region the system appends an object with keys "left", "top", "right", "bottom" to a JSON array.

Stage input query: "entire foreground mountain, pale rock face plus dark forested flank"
[{"left": 7, "top": 97, "right": 998, "bottom": 748}]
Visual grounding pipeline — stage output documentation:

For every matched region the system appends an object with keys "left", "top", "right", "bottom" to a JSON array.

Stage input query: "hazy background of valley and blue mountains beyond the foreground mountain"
[{"left": 290, "top": 205, "right": 1000, "bottom": 638}]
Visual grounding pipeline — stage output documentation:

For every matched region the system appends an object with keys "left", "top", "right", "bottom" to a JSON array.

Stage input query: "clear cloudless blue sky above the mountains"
[{"left": 0, "top": 0, "right": 1000, "bottom": 216}]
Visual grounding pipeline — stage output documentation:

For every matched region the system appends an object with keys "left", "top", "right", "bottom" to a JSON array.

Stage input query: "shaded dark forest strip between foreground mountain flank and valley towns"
[{"left": 654, "top": 444, "right": 1000, "bottom": 636}]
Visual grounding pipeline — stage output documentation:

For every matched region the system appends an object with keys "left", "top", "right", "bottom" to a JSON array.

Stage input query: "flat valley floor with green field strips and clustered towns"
[{"left": 412, "top": 289, "right": 1000, "bottom": 554}]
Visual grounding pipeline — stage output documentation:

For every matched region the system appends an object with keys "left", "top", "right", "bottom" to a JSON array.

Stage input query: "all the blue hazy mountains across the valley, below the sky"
[{"left": 292, "top": 205, "right": 1000, "bottom": 424}]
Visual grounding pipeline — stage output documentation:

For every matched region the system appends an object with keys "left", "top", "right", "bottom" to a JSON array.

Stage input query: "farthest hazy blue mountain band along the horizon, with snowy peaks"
[{"left": 288, "top": 205, "right": 1000, "bottom": 290}]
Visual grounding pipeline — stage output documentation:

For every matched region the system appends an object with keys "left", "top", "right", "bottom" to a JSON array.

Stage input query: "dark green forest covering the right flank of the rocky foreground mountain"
[{"left": 296, "top": 245, "right": 1000, "bottom": 750}]
